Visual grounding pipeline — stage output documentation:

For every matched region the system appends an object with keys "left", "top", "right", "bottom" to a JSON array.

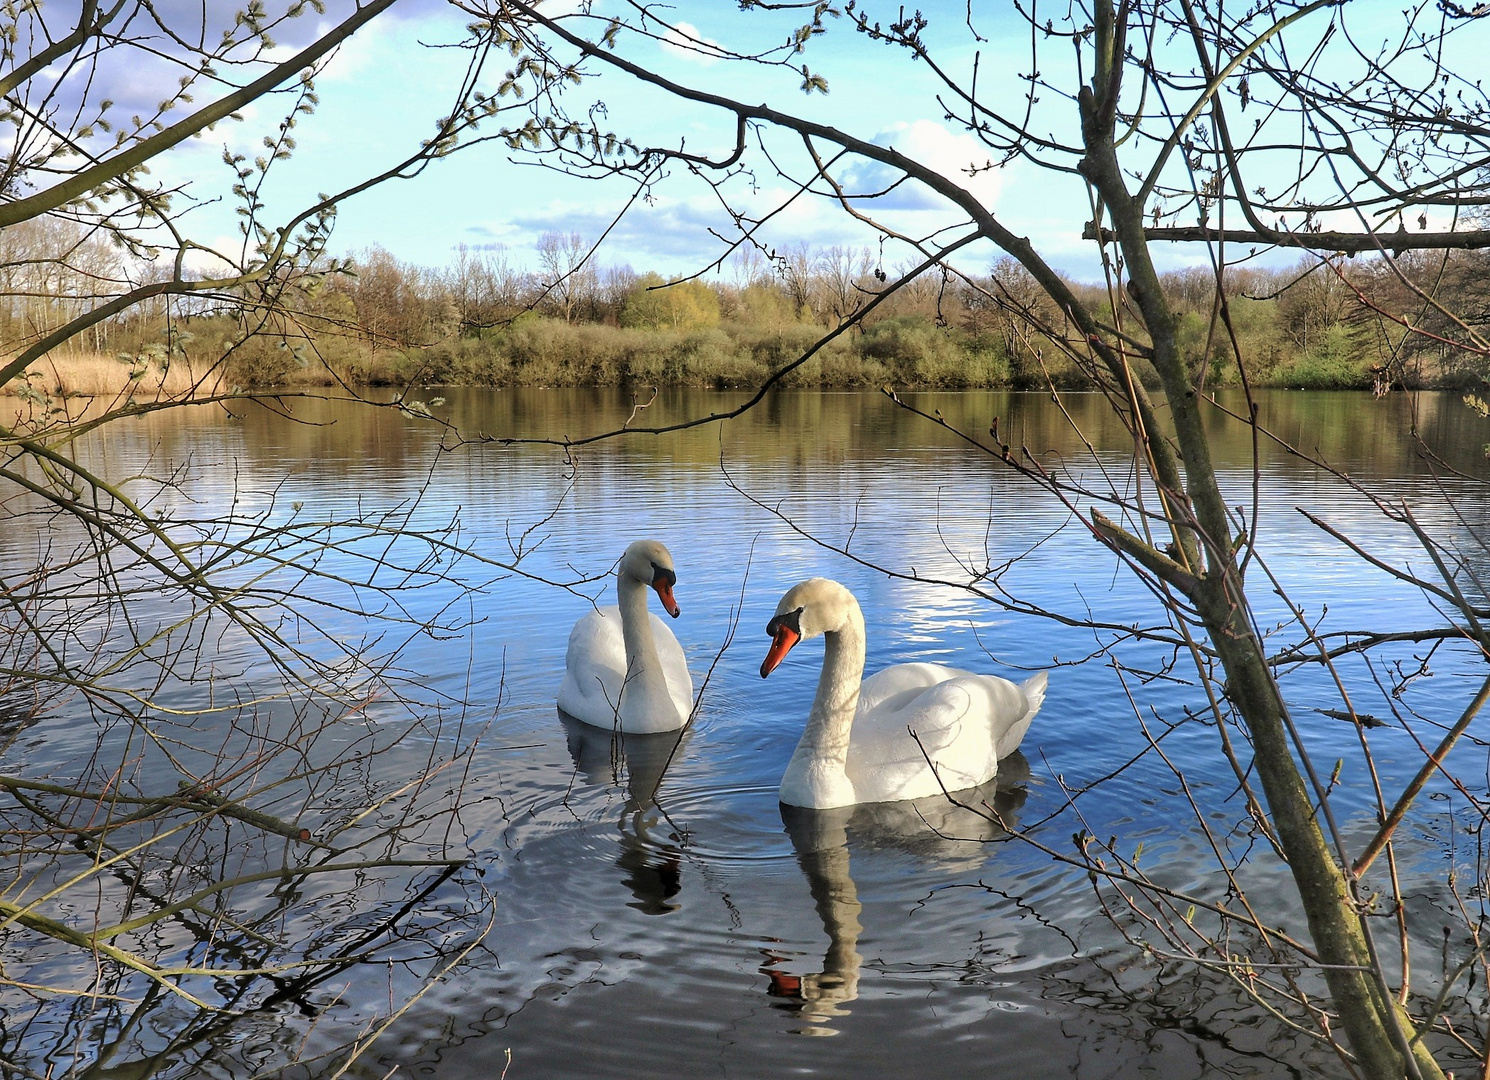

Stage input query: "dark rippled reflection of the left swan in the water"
[{"left": 559, "top": 712, "right": 687, "bottom": 915}]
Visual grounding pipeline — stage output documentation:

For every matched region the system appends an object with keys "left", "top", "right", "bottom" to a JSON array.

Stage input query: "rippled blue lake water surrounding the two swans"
[{"left": 0, "top": 390, "right": 1490, "bottom": 1079}]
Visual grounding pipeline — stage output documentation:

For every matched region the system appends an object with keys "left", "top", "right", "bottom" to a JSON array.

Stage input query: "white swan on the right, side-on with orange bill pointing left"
[{"left": 760, "top": 578, "right": 1046, "bottom": 809}]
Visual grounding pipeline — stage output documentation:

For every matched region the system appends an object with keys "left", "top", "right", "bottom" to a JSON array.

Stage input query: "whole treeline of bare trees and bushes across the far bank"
[{"left": 0, "top": 223, "right": 1490, "bottom": 389}]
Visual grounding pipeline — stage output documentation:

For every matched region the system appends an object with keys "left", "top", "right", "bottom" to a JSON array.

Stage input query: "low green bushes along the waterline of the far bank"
[{"left": 234, "top": 314, "right": 1374, "bottom": 390}]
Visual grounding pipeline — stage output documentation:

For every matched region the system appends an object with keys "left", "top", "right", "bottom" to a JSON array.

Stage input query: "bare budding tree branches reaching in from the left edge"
[{"left": 0, "top": 0, "right": 575, "bottom": 1076}]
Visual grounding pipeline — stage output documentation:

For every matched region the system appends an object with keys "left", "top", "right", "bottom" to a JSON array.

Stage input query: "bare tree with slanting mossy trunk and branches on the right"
[{"left": 469, "top": 0, "right": 1490, "bottom": 1077}]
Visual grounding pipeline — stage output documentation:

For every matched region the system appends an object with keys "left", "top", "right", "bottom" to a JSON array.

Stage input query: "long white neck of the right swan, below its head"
[{"left": 781, "top": 605, "right": 864, "bottom": 809}]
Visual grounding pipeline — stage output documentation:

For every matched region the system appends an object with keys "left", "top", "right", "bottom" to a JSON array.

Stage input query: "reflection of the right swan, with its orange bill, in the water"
[{"left": 760, "top": 751, "right": 1030, "bottom": 1035}]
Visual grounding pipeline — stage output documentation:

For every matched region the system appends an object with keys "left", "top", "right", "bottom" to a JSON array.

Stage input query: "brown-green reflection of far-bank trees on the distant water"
[{"left": 414, "top": 386, "right": 1490, "bottom": 478}]
